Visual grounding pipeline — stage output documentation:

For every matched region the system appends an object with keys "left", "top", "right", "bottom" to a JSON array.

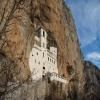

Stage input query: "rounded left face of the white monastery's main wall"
[{"left": 29, "top": 46, "right": 43, "bottom": 80}]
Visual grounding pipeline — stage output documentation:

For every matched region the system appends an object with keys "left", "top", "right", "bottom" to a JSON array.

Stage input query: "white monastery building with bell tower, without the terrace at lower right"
[{"left": 29, "top": 29, "right": 58, "bottom": 80}]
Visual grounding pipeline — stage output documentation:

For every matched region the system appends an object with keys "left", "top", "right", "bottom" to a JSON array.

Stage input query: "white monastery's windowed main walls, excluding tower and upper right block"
[{"left": 29, "top": 45, "right": 58, "bottom": 80}]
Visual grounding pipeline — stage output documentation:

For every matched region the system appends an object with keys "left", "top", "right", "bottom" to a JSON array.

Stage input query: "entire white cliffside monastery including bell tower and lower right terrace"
[{"left": 29, "top": 28, "right": 66, "bottom": 83}]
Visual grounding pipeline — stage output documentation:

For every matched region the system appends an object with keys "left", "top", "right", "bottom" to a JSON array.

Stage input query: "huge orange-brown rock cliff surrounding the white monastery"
[{"left": 0, "top": 0, "right": 84, "bottom": 100}]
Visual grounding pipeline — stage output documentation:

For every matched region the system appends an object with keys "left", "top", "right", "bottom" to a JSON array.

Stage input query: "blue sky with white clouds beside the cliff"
[{"left": 65, "top": 0, "right": 100, "bottom": 68}]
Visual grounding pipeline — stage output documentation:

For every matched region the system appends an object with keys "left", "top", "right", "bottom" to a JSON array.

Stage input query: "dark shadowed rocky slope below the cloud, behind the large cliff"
[{"left": 83, "top": 61, "right": 100, "bottom": 100}]
